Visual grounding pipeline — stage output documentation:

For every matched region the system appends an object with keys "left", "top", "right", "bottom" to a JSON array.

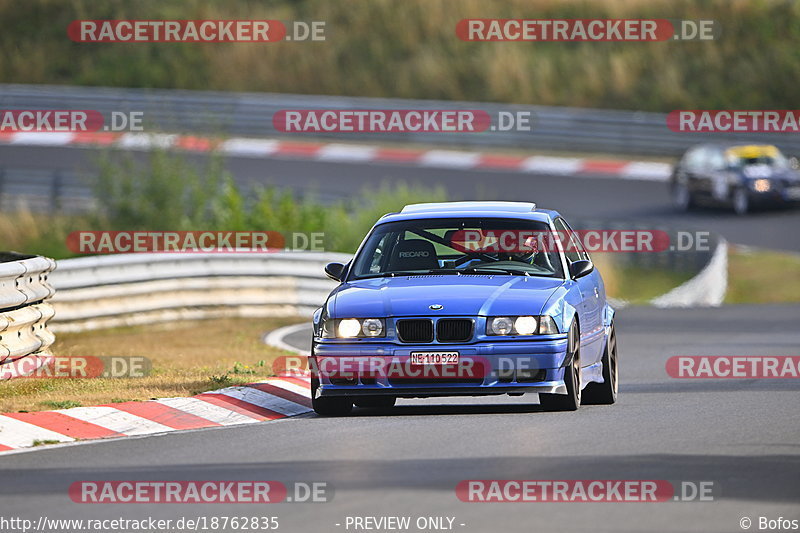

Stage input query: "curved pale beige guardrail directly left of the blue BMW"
[{"left": 52, "top": 252, "right": 350, "bottom": 331}]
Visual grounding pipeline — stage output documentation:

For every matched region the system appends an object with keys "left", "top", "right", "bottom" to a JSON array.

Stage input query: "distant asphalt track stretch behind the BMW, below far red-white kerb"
[{"left": 0, "top": 145, "right": 800, "bottom": 252}]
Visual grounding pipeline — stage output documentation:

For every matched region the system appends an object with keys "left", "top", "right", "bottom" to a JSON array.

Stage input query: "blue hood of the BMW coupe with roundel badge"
[{"left": 331, "top": 275, "right": 564, "bottom": 318}]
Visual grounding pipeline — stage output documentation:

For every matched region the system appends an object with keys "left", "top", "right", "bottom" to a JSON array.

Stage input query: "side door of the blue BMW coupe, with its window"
[{"left": 554, "top": 218, "right": 605, "bottom": 366}]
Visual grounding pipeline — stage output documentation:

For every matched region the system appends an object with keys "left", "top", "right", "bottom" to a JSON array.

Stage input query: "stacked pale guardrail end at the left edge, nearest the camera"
[{"left": 0, "top": 252, "right": 56, "bottom": 379}]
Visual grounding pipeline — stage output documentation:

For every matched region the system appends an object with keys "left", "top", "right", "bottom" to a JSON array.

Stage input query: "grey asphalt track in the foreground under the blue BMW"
[{"left": 0, "top": 305, "right": 800, "bottom": 533}]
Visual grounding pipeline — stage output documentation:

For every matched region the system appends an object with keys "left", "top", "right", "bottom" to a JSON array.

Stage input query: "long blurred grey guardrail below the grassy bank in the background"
[{"left": 0, "top": 84, "right": 800, "bottom": 156}]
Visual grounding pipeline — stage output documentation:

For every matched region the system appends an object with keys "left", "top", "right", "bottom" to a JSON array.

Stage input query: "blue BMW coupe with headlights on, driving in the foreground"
[{"left": 309, "top": 202, "right": 618, "bottom": 416}]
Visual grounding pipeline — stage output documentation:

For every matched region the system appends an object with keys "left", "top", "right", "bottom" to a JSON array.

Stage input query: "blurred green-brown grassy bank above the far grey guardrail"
[{"left": 0, "top": 0, "right": 800, "bottom": 111}]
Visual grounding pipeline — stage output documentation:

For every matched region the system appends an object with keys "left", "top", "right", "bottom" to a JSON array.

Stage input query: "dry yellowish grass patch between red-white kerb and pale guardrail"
[{"left": 0, "top": 317, "right": 298, "bottom": 412}]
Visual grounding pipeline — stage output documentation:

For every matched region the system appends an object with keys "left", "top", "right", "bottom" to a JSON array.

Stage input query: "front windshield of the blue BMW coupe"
[{"left": 350, "top": 218, "right": 563, "bottom": 279}]
